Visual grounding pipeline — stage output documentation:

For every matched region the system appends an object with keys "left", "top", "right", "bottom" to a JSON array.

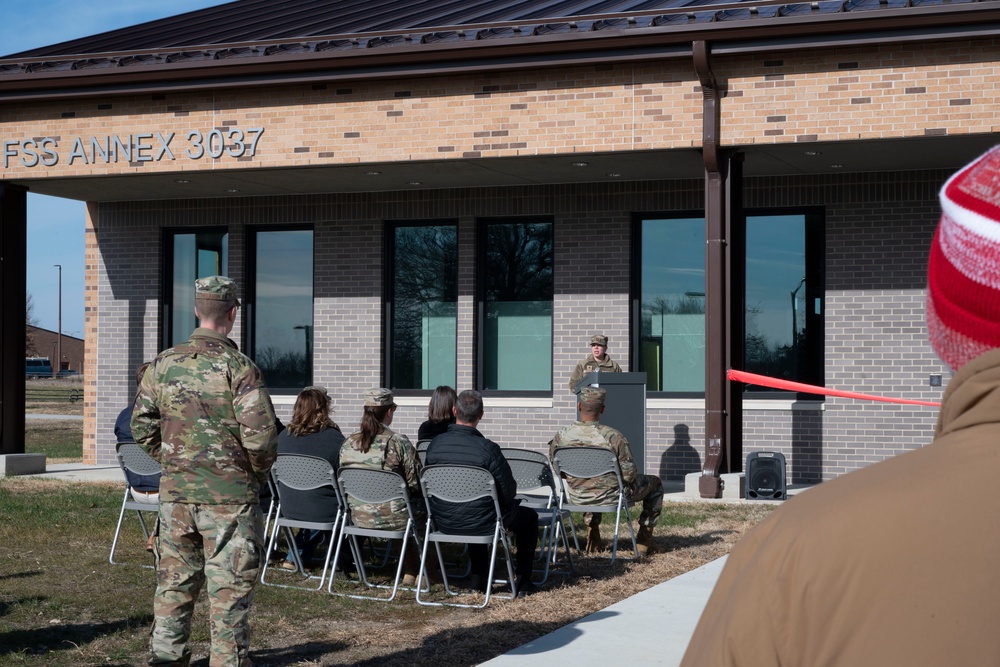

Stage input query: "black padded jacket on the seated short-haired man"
[{"left": 424, "top": 424, "right": 520, "bottom": 535}]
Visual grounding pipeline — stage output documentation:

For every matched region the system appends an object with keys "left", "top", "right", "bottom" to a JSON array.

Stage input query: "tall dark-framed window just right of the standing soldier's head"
[{"left": 244, "top": 228, "right": 314, "bottom": 394}]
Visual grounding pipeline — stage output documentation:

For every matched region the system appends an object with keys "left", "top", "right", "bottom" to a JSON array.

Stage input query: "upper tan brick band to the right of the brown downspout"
[{"left": 716, "top": 39, "right": 1000, "bottom": 145}]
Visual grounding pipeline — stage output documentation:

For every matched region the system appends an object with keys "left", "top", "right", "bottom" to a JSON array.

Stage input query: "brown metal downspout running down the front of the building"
[{"left": 692, "top": 41, "right": 732, "bottom": 498}]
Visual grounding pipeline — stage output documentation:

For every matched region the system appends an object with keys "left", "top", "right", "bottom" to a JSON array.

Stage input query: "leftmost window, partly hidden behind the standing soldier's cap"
[{"left": 163, "top": 229, "right": 229, "bottom": 349}]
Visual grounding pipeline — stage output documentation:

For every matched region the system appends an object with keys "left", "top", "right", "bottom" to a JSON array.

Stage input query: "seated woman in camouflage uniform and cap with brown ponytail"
[{"left": 340, "top": 389, "right": 426, "bottom": 586}]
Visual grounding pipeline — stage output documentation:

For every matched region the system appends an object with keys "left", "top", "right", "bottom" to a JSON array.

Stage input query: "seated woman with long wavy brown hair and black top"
[{"left": 278, "top": 387, "right": 344, "bottom": 570}]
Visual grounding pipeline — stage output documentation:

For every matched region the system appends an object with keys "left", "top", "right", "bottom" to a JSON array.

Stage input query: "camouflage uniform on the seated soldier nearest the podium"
[{"left": 549, "top": 421, "right": 663, "bottom": 528}]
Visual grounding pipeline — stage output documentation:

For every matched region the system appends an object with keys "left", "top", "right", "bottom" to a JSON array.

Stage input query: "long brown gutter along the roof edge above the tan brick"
[{"left": 0, "top": 3, "right": 1000, "bottom": 101}]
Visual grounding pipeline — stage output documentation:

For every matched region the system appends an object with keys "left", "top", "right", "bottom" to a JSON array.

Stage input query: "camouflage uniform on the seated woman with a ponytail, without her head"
[{"left": 340, "top": 425, "right": 423, "bottom": 530}]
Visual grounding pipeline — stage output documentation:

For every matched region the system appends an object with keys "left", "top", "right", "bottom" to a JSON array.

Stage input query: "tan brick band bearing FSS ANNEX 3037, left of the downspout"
[{"left": 0, "top": 61, "right": 701, "bottom": 178}]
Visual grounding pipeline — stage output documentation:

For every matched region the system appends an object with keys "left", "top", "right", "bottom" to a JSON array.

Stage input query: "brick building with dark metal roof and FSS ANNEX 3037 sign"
[{"left": 0, "top": 0, "right": 1000, "bottom": 482}]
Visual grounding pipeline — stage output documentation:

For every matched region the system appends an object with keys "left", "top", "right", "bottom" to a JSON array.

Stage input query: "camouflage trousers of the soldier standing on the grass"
[{"left": 149, "top": 503, "right": 263, "bottom": 667}]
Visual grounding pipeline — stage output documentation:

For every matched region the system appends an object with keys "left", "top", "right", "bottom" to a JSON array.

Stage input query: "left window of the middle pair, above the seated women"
[{"left": 385, "top": 223, "right": 458, "bottom": 390}]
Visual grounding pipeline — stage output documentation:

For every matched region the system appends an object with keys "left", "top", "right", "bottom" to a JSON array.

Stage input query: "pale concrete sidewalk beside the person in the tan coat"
[{"left": 482, "top": 557, "right": 726, "bottom": 667}]
